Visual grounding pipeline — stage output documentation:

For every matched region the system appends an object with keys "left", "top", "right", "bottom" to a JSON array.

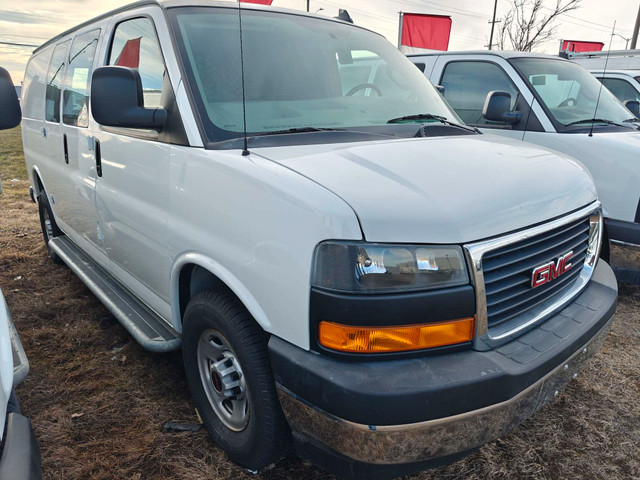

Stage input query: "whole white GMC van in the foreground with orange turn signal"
[{"left": 22, "top": 4, "right": 617, "bottom": 478}]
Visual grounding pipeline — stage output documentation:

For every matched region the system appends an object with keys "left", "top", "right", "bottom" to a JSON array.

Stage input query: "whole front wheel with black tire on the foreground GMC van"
[{"left": 182, "top": 292, "right": 291, "bottom": 470}]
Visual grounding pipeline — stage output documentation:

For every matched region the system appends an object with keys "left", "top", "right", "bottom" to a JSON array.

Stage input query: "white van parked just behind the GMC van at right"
[{"left": 410, "top": 51, "right": 640, "bottom": 279}]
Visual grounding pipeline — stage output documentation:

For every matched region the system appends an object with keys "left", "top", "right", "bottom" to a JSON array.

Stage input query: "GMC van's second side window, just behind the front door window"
[{"left": 62, "top": 30, "right": 100, "bottom": 127}]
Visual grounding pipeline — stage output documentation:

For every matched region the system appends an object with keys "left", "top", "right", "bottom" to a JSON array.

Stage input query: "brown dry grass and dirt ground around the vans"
[{"left": 0, "top": 126, "right": 640, "bottom": 480}]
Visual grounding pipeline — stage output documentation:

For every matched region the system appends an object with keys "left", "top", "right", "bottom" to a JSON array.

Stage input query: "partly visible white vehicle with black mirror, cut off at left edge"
[{"left": 0, "top": 67, "right": 42, "bottom": 480}]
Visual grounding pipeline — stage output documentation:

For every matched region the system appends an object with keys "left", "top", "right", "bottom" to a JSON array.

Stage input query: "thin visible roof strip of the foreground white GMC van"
[{"left": 33, "top": 0, "right": 360, "bottom": 54}]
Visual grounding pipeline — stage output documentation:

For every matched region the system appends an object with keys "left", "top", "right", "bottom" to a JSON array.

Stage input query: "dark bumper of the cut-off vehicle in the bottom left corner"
[{"left": 0, "top": 413, "right": 42, "bottom": 480}]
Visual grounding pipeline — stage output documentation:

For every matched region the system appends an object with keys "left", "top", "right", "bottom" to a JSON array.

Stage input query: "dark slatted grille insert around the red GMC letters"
[{"left": 482, "top": 217, "right": 590, "bottom": 328}]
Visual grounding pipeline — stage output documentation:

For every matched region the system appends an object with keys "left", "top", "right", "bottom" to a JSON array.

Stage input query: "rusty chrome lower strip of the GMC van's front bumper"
[{"left": 278, "top": 321, "right": 611, "bottom": 465}]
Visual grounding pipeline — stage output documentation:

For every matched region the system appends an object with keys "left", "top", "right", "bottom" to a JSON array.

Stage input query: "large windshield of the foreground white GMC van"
[{"left": 171, "top": 8, "right": 462, "bottom": 141}]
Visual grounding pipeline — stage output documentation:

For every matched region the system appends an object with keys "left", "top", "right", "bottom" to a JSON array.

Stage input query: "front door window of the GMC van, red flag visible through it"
[{"left": 109, "top": 18, "right": 165, "bottom": 108}]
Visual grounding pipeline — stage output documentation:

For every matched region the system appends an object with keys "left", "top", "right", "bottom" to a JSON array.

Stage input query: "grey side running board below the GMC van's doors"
[{"left": 49, "top": 236, "right": 181, "bottom": 352}]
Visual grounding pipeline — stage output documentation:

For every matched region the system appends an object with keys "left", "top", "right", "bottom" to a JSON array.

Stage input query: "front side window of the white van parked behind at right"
[{"left": 440, "top": 62, "right": 518, "bottom": 125}]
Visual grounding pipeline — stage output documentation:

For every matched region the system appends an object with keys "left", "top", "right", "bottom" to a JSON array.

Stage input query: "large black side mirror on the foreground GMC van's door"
[{"left": 91, "top": 67, "right": 167, "bottom": 130}]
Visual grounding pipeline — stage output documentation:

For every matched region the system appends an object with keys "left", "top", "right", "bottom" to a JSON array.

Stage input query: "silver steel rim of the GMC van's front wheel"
[{"left": 197, "top": 329, "right": 249, "bottom": 432}]
